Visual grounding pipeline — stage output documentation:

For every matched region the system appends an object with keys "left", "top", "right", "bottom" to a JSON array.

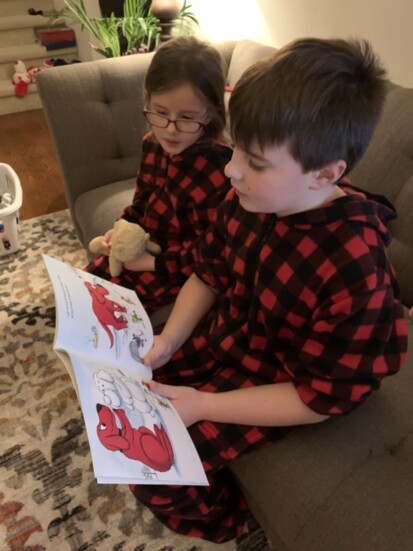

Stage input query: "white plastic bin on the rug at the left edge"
[{"left": 0, "top": 163, "right": 23, "bottom": 256}]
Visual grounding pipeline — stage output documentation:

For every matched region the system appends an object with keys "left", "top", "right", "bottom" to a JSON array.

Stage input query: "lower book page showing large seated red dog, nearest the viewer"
[{"left": 70, "top": 353, "right": 208, "bottom": 485}]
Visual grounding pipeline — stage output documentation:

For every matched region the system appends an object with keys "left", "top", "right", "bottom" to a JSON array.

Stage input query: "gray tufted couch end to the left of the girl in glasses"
[{"left": 37, "top": 54, "right": 152, "bottom": 247}]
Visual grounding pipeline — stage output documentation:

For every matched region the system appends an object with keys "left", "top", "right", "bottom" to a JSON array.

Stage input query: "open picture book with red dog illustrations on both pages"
[{"left": 43, "top": 255, "right": 208, "bottom": 485}]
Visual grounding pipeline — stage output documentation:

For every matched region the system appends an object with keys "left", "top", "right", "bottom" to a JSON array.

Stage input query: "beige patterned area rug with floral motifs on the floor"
[{"left": 0, "top": 210, "right": 269, "bottom": 551}]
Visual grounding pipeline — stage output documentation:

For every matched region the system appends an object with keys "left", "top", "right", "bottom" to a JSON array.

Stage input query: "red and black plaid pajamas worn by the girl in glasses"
[{"left": 86, "top": 132, "right": 231, "bottom": 312}]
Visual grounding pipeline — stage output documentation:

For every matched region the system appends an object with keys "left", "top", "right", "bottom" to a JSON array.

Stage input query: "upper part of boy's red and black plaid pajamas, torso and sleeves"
[{"left": 192, "top": 182, "right": 407, "bottom": 415}]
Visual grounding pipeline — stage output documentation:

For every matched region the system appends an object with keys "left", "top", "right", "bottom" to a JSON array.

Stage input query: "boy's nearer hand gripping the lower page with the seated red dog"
[{"left": 148, "top": 381, "right": 208, "bottom": 427}]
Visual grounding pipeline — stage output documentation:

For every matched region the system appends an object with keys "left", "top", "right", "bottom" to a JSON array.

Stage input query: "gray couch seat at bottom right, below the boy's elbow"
[{"left": 231, "top": 314, "right": 413, "bottom": 551}]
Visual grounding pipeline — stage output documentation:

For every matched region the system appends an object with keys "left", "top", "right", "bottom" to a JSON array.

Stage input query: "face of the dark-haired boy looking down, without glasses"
[{"left": 225, "top": 141, "right": 318, "bottom": 216}]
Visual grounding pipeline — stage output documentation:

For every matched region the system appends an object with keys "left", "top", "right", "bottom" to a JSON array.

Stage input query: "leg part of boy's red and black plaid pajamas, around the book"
[{"left": 130, "top": 337, "right": 291, "bottom": 543}]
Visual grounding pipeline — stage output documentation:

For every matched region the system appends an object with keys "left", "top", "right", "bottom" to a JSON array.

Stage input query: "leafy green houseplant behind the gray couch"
[{"left": 50, "top": 0, "right": 198, "bottom": 57}]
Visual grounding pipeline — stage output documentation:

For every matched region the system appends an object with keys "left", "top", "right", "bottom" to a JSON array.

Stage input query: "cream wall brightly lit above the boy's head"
[{"left": 190, "top": 0, "right": 413, "bottom": 87}]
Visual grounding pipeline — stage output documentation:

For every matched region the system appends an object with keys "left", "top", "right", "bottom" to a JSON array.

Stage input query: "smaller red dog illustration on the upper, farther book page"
[{"left": 85, "top": 281, "right": 128, "bottom": 348}]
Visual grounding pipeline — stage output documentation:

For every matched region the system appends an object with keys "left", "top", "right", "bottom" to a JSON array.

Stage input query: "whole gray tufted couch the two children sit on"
[{"left": 37, "top": 41, "right": 413, "bottom": 551}]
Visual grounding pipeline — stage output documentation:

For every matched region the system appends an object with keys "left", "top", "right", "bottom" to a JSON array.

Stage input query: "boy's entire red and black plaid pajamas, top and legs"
[{"left": 133, "top": 183, "right": 407, "bottom": 542}]
